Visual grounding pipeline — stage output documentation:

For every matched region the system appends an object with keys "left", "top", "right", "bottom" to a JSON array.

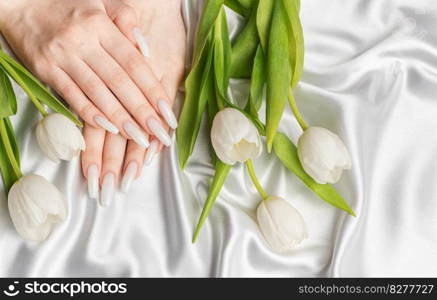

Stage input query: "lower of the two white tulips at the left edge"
[{"left": 8, "top": 174, "right": 67, "bottom": 242}]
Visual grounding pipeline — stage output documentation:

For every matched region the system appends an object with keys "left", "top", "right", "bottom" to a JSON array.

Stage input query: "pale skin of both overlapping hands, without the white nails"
[{"left": 0, "top": 0, "right": 185, "bottom": 202}]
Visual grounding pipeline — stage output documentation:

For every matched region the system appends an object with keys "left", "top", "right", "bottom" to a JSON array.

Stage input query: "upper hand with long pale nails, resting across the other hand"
[{"left": 0, "top": 0, "right": 175, "bottom": 148}]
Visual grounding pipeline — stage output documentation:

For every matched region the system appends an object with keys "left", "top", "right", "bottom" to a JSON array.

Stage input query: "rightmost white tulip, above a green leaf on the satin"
[{"left": 297, "top": 127, "right": 352, "bottom": 184}]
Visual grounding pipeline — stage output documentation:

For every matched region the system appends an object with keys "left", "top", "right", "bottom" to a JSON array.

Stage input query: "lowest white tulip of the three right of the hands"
[{"left": 257, "top": 196, "right": 308, "bottom": 253}]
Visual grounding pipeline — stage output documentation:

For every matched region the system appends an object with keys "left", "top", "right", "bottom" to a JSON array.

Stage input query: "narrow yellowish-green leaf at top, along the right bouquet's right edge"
[{"left": 282, "top": 0, "right": 304, "bottom": 88}]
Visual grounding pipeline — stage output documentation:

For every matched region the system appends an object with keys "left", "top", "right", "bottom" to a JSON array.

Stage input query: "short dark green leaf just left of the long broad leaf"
[{"left": 246, "top": 44, "right": 266, "bottom": 118}]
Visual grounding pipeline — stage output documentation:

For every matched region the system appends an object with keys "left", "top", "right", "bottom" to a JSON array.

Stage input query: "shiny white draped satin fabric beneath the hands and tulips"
[{"left": 0, "top": 0, "right": 437, "bottom": 277}]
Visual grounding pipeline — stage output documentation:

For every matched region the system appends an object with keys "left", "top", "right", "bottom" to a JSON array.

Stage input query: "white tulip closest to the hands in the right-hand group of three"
[{"left": 211, "top": 108, "right": 262, "bottom": 165}]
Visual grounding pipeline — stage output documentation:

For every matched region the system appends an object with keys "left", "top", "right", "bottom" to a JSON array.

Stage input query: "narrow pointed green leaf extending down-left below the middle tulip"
[{"left": 193, "top": 160, "right": 232, "bottom": 243}]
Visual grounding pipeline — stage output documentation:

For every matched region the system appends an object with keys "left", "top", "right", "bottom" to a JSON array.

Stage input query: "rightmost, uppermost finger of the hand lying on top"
[{"left": 101, "top": 26, "right": 177, "bottom": 133}]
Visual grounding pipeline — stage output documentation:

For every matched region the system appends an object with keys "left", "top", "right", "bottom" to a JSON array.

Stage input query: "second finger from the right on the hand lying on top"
[{"left": 84, "top": 50, "right": 169, "bottom": 144}]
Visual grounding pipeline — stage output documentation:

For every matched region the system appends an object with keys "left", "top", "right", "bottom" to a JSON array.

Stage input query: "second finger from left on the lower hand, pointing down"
[{"left": 100, "top": 133, "right": 127, "bottom": 206}]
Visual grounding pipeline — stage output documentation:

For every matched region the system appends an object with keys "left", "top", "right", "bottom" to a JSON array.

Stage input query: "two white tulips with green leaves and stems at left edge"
[{"left": 0, "top": 45, "right": 85, "bottom": 242}]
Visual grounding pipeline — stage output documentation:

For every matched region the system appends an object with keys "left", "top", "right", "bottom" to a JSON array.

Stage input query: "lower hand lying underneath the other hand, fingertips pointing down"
[{"left": 82, "top": 0, "right": 186, "bottom": 205}]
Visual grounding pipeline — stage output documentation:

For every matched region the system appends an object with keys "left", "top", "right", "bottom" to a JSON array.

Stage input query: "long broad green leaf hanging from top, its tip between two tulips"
[{"left": 266, "top": 1, "right": 291, "bottom": 152}]
